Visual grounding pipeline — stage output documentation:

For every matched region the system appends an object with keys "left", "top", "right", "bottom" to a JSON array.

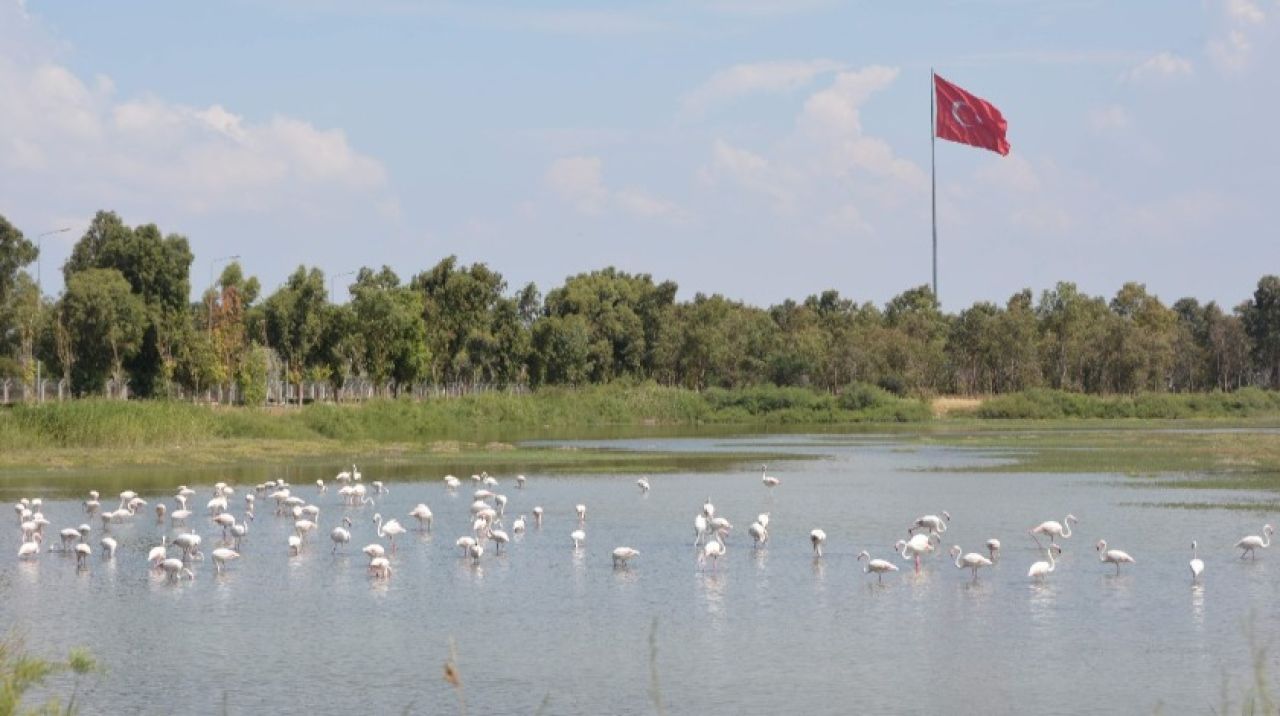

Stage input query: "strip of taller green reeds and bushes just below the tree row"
[{"left": 0, "top": 384, "right": 1280, "bottom": 451}]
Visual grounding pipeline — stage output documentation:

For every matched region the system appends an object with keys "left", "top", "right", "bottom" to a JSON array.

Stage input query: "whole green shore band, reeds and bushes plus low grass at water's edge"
[{"left": 0, "top": 384, "right": 1280, "bottom": 473}]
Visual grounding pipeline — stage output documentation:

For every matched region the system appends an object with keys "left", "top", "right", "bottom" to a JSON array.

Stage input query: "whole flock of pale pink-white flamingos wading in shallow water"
[{"left": 14, "top": 465, "right": 1275, "bottom": 582}]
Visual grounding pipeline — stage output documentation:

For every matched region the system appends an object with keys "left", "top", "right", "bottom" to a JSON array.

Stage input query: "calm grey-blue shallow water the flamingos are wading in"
[{"left": 0, "top": 435, "right": 1280, "bottom": 715}]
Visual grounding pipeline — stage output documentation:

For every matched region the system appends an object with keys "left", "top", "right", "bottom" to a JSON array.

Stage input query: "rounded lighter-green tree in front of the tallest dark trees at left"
[{"left": 63, "top": 269, "right": 147, "bottom": 395}]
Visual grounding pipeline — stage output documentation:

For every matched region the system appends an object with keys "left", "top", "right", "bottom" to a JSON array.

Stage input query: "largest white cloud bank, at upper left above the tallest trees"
[{"left": 0, "top": 3, "right": 394, "bottom": 213}]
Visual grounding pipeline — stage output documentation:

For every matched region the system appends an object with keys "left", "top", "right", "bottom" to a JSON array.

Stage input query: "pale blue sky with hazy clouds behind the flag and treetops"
[{"left": 0, "top": 0, "right": 1280, "bottom": 310}]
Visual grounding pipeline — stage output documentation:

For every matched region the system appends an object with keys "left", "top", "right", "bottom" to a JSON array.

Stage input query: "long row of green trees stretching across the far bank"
[{"left": 0, "top": 211, "right": 1280, "bottom": 403}]
